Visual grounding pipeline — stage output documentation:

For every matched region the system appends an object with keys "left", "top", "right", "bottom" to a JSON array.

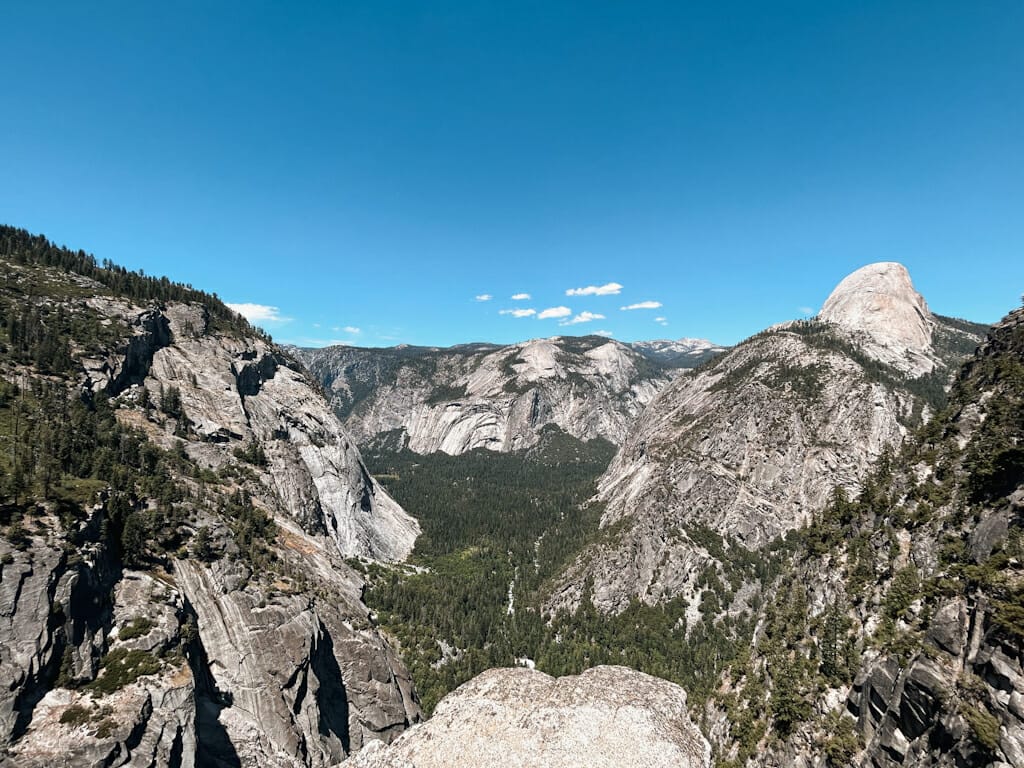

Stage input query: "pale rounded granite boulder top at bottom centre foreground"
[{"left": 349, "top": 667, "right": 711, "bottom": 768}]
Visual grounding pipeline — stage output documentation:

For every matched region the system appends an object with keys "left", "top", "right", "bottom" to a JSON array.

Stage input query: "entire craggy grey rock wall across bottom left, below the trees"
[{"left": 0, "top": 509, "right": 420, "bottom": 768}]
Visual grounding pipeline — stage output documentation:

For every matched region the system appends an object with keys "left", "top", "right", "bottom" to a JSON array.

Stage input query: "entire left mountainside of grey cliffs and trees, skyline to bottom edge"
[{"left": 0, "top": 236, "right": 420, "bottom": 768}]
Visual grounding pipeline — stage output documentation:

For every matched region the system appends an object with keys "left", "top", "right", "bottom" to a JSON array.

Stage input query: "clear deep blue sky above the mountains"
[{"left": 0, "top": 0, "right": 1024, "bottom": 345}]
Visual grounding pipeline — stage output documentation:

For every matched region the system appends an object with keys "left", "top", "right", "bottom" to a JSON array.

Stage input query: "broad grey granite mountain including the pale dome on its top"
[{"left": 551, "top": 264, "right": 980, "bottom": 611}]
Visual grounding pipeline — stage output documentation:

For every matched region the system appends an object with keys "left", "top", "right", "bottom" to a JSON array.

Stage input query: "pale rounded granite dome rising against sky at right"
[{"left": 818, "top": 261, "right": 935, "bottom": 376}]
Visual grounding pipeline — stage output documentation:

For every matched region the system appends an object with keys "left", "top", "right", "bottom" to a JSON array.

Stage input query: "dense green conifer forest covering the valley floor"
[{"left": 362, "top": 429, "right": 792, "bottom": 712}]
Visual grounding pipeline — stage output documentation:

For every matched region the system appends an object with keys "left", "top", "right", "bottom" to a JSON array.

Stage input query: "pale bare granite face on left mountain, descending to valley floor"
[{"left": 145, "top": 305, "right": 419, "bottom": 560}]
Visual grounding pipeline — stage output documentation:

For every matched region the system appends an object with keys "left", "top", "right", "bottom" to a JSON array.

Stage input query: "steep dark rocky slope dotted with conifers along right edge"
[{"left": 706, "top": 309, "right": 1024, "bottom": 768}]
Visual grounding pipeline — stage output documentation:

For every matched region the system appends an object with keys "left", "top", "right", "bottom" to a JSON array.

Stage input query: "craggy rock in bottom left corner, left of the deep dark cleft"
[{"left": 0, "top": 518, "right": 197, "bottom": 768}]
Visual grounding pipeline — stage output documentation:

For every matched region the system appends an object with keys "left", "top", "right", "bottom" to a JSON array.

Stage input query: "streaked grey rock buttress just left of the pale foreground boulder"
[{"left": 175, "top": 562, "right": 418, "bottom": 766}]
